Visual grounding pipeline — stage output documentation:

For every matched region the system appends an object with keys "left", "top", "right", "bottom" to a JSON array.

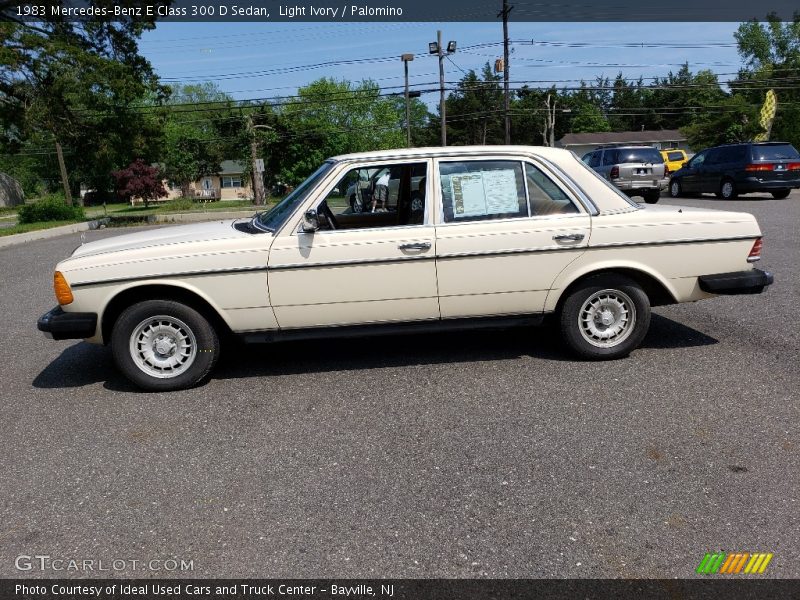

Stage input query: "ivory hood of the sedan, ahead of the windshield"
[{"left": 72, "top": 219, "right": 248, "bottom": 258}]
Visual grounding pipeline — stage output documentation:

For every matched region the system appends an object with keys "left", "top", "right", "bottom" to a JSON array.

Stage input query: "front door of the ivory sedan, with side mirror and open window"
[{"left": 268, "top": 160, "right": 439, "bottom": 329}]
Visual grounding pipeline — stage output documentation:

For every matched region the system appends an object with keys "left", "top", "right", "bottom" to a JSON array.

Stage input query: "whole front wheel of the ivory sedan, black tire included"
[{"left": 111, "top": 300, "right": 220, "bottom": 392}]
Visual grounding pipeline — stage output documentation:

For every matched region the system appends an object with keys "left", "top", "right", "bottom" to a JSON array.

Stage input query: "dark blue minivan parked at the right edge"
[{"left": 669, "top": 142, "right": 800, "bottom": 200}]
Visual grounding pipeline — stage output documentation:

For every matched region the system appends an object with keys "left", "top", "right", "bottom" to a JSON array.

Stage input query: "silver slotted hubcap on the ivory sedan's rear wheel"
[{"left": 578, "top": 290, "right": 636, "bottom": 348}]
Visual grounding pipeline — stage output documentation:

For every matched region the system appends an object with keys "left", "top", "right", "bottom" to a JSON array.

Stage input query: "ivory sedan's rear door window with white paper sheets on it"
[{"left": 439, "top": 160, "right": 528, "bottom": 223}]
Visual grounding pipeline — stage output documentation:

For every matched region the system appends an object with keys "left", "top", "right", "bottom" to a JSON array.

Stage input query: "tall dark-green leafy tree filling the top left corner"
[{"left": 0, "top": 0, "right": 163, "bottom": 204}]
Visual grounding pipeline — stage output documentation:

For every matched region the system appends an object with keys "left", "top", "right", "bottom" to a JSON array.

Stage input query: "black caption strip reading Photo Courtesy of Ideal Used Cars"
[{"left": 0, "top": 577, "right": 800, "bottom": 600}]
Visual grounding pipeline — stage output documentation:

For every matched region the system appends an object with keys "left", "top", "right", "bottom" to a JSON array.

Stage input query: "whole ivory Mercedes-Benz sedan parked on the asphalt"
[{"left": 38, "top": 146, "right": 772, "bottom": 390}]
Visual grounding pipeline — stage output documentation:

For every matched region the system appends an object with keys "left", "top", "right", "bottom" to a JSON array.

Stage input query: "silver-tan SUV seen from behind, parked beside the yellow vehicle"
[{"left": 581, "top": 146, "right": 667, "bottom": 204}]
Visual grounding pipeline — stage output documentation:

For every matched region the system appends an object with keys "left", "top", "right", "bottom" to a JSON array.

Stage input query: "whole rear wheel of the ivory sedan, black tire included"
[{"left": 559, "top": 275, "right": 650, "bottom": 360}]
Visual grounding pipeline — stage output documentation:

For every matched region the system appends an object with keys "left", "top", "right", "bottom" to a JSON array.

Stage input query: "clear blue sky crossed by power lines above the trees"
[{"left": 140, "top": 21, "right": 741, "bottom": 106}]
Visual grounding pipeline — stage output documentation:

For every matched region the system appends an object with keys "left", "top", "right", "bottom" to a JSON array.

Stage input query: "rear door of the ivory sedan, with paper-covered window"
[{"left": 434, "top": 157, "right": 591, "bottom": 319}]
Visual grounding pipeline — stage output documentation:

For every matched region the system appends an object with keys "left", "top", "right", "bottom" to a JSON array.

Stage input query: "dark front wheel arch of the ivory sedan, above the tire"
[{"left": 100, "top": 282, "right": 231, "bottom": 344}]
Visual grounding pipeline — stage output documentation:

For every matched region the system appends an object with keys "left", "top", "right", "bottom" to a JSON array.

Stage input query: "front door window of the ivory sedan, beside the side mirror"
[{"left": 317, "top": 163, "right": 428, "bottom": 230}]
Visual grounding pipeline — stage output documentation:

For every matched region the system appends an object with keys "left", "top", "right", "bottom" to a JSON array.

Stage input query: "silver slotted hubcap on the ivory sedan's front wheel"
[{"left": 130, "top": 315, "right": 197, "bottom": 379}]
